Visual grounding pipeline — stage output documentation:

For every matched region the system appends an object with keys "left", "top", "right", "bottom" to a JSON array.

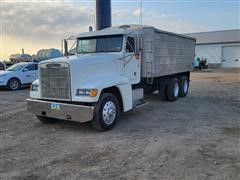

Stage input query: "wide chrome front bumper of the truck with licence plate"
[{"left": 26, "top": 99, "right": 94, "bottom": 122}]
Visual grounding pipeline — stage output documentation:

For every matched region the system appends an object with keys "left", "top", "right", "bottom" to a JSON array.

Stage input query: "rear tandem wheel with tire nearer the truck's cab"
[{"left": 167, "top": 78, "right": 179, "bottom": 101}]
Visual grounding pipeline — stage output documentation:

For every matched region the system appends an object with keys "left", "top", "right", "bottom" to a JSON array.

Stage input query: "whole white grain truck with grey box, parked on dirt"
[{"left": 27, "top": 25, "right": 195, "bottom": 131}]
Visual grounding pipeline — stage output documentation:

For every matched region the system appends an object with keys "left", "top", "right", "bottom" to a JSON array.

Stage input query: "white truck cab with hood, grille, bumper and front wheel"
[{"left": 27, "top": 27, "right": 143, "bottom": 130}]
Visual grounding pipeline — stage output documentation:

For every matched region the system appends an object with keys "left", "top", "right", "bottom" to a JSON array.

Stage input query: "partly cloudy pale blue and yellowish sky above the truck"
[{"left": 0, "top": 0, "right": 240, "bottom": 60}]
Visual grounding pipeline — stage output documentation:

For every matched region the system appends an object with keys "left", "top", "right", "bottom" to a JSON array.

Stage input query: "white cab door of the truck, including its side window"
[{"left": 124, "top": 36, "right": 141, "bottom": 84}]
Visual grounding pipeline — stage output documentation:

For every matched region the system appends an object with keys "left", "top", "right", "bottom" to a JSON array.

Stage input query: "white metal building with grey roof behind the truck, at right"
[{"left": 186, "top": 29, "right": 240, "bottom": 68}]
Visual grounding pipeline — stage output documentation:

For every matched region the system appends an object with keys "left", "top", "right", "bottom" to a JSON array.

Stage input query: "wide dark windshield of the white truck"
[{"left": 77, "top": 35, "right": 123, "bottom": 54}]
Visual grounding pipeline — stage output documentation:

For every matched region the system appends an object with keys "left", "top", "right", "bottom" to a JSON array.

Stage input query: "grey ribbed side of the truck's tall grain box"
[{"left": 142, "top": 29, "right": 195, "bottom": 77}]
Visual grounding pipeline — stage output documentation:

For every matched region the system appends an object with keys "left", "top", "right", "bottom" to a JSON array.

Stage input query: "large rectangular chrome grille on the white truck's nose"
[{"left": 40, "top": 63, "right": 70, "bottom": 100}]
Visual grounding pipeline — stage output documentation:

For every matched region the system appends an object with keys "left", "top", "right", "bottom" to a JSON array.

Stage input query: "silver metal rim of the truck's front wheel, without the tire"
[{"left": 102, "top": 101, "right": 117, "bottom": 125}]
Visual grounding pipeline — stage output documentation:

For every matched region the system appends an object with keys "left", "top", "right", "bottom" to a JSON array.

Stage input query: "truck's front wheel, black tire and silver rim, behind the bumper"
[{"left": 92, "top": 93, "right": 119, "bottom": 131}]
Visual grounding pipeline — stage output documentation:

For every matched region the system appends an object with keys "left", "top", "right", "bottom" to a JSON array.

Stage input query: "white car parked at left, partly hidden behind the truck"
[{"left": 0, "top": 62, "right": 38, "bottom": 90}]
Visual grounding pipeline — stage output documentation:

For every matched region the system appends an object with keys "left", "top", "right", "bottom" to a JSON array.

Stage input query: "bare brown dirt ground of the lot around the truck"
[{"left": 0, "top": 70, "right": 240, "bottom": 180}]
